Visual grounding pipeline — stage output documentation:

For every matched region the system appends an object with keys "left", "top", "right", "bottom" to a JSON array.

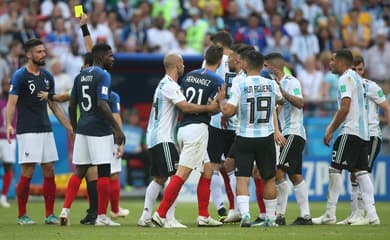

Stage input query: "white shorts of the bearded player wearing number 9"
[{"left": 16, "top": 132, "right": 58, "bottom": 164}]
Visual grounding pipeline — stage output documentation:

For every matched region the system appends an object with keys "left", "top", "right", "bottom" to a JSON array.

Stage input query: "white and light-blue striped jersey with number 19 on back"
[{"left": 228, "top": 76, "right": 283, "bottom": 138}]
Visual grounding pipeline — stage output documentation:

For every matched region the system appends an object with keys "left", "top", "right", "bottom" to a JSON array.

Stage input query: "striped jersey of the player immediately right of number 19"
[{"left": 279, "top": 75, "right": 306, "bottom": 140}]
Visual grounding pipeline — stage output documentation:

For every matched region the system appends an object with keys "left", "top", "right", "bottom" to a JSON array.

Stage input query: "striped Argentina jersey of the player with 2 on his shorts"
[{"left": 338, "top": 69, "right": 370, "bottom": 141}]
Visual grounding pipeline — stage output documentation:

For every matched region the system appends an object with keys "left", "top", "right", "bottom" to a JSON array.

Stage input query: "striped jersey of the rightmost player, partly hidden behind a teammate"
[{"left": 364, "top": 79, "right": 386, "bottom": 138}]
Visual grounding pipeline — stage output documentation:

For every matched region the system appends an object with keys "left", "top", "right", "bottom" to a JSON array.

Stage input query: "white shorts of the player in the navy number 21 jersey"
[{"left": 177, "top": 123, "right": 210, "bottom": 172}]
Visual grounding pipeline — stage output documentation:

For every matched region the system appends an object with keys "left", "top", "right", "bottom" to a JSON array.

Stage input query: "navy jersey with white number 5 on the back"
[{"left": 71, "top": 66, "right": 112, "bottom": 136}]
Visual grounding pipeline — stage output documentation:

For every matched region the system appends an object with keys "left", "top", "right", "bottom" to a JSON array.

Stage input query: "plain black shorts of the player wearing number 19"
[{"left": 234, "top": 134, "right": 276, "bottom": 179}]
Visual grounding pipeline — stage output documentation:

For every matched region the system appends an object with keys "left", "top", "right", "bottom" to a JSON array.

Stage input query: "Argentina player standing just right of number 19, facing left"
[{"left": 265, "top": 53, "right": 313, "bottom": 225}]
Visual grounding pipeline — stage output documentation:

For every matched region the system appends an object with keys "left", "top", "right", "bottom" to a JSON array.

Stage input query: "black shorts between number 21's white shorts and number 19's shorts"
[{"left": 207, "top": 126, "right": 236, "bottom": 163}]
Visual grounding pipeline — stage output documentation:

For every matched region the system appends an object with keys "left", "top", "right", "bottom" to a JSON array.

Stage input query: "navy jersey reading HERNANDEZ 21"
[{"left": 181, "top": 68, "right": 224, "bottom": 126}]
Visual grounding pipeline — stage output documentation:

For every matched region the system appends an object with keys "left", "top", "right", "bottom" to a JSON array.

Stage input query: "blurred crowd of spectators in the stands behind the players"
[{"left": 0, "top": 0, "right": 390, "bottom": 105}]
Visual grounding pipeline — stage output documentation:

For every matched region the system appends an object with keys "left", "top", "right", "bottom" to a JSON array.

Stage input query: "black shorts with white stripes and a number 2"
[{"left": 331, "top": 134, "right": 369, "bottom": 172}]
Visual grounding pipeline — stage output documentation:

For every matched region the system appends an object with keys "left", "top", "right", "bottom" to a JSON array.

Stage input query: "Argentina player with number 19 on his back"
[{"left": 218, "top": 51, "right": 283, "bottom": 227}]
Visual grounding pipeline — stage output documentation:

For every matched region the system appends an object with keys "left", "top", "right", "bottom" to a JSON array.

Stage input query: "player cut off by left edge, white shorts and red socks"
[{"left": 0, "top": 76, "right": 16, "bottom": 208}]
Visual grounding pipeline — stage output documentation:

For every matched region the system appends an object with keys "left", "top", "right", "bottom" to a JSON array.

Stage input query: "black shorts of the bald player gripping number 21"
[{"left": 149, "top": 142, "right": 179, "bottom": 177}]
